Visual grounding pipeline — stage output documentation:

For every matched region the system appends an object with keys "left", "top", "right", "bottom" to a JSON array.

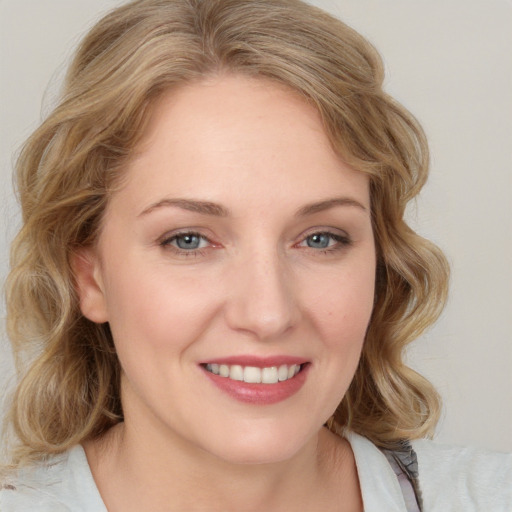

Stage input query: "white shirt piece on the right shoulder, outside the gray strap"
[{"left": 412, "top": 439, "right": 512, "bottom": 512}]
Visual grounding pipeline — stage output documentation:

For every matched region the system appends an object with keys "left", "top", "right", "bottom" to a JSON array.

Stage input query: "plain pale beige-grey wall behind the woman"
[{"left": 0, "top": 0, "right": 512, "bottom": 451}]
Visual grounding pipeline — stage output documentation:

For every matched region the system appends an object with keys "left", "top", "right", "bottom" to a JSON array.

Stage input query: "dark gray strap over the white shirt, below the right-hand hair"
[{"left": 382, "top": 441, "right": 423, "bottom": 512}]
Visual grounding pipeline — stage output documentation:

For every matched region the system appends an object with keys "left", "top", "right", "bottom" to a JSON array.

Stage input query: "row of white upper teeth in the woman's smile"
[{"left": 206, "top": 363, "right": 301, "bottom": 384}]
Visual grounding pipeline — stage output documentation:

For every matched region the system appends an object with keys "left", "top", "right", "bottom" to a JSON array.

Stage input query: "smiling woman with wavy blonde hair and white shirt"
[{"left": 0, "top": 0, "right": 512, "bottom": 512}]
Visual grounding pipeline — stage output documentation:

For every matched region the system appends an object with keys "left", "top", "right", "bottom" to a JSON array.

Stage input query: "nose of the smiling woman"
[{"left": 225, "top": 247, "right": 300, "bottom": 340}]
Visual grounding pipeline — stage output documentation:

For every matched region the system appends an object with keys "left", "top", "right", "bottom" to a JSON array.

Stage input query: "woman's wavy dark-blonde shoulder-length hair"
[{"left": 3, "top": 0, "right": 448, "bottom": 464}]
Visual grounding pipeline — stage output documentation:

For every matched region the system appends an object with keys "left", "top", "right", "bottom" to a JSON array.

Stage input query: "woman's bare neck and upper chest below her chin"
[{"left": 86, "top": 424, "right": 362, "bottom": 512}]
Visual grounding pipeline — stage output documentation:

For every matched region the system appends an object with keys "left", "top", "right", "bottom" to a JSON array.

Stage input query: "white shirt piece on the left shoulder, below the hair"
[{"left": 0, "top": 446, "right": 106, "bottom": 512}]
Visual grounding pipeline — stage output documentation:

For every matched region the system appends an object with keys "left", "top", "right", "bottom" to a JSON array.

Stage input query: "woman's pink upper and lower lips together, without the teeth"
[{"left": 199, "top": 356, "right": 311, "bottom": 405}]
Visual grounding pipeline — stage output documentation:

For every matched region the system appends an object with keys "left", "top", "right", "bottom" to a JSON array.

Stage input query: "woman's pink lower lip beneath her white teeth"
[{"left": 201, "top": 364, "right": 310, "bottom": 405}]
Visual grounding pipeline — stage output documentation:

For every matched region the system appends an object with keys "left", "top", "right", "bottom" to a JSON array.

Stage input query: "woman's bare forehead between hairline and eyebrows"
[{"left": 111, "top": 75, "right": 369, "bottom": 214}]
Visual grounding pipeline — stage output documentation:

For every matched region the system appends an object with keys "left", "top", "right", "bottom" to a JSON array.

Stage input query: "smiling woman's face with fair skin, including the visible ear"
[{"left": 78, "top": 76, "right": 375, "bottom": 463}]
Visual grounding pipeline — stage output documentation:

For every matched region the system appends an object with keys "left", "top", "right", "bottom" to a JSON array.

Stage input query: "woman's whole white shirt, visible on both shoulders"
[{"left": 0, "top": 432, "right": 512, "bottom": 512}]
